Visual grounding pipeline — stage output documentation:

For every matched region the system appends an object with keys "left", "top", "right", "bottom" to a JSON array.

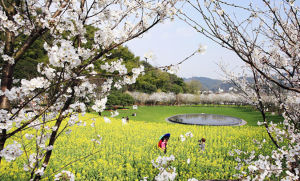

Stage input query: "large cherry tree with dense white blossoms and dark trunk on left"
[{"left": 0, "top": 0, "right": 183, "bottom": 180}]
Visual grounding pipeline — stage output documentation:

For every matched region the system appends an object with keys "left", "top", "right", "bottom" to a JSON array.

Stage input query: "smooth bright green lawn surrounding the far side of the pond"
[{"left": 95, "top": 106, "right": 282, "bottom": 126}]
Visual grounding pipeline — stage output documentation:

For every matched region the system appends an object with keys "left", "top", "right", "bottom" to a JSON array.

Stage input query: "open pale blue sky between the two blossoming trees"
[{"left": 126, "top": 17, "right": 243, "bottom": 79}]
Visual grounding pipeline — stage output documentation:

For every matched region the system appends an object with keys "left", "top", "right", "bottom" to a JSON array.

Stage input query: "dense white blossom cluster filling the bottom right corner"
[{"left": 229, "top": 121, "right": 300, "bottom": 180}]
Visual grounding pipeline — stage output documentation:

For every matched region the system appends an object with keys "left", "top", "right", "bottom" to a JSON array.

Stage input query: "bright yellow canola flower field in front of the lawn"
[{"left": 0, "top": 114, "right": 272, "bottom": 181}]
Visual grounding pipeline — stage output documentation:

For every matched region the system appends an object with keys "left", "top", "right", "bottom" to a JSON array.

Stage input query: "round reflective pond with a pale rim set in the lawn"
[{"left": 167, "top": 113, "right": 245, "bottom": 126}]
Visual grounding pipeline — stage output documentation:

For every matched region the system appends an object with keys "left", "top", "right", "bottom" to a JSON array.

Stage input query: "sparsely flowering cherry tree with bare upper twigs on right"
[{"left": 178, "top": 0, "right": 300, "bottom": 180}]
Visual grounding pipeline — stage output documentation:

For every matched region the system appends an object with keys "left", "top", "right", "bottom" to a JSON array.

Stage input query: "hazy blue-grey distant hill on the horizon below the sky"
[{"left": 184, "top": 77, "right": 234, "bottom": 92}]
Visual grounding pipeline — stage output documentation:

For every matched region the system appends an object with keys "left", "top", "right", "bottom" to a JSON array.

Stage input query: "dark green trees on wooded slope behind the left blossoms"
[{"left": 0, "top": 34, "right": 202, "bottom": 108}]
